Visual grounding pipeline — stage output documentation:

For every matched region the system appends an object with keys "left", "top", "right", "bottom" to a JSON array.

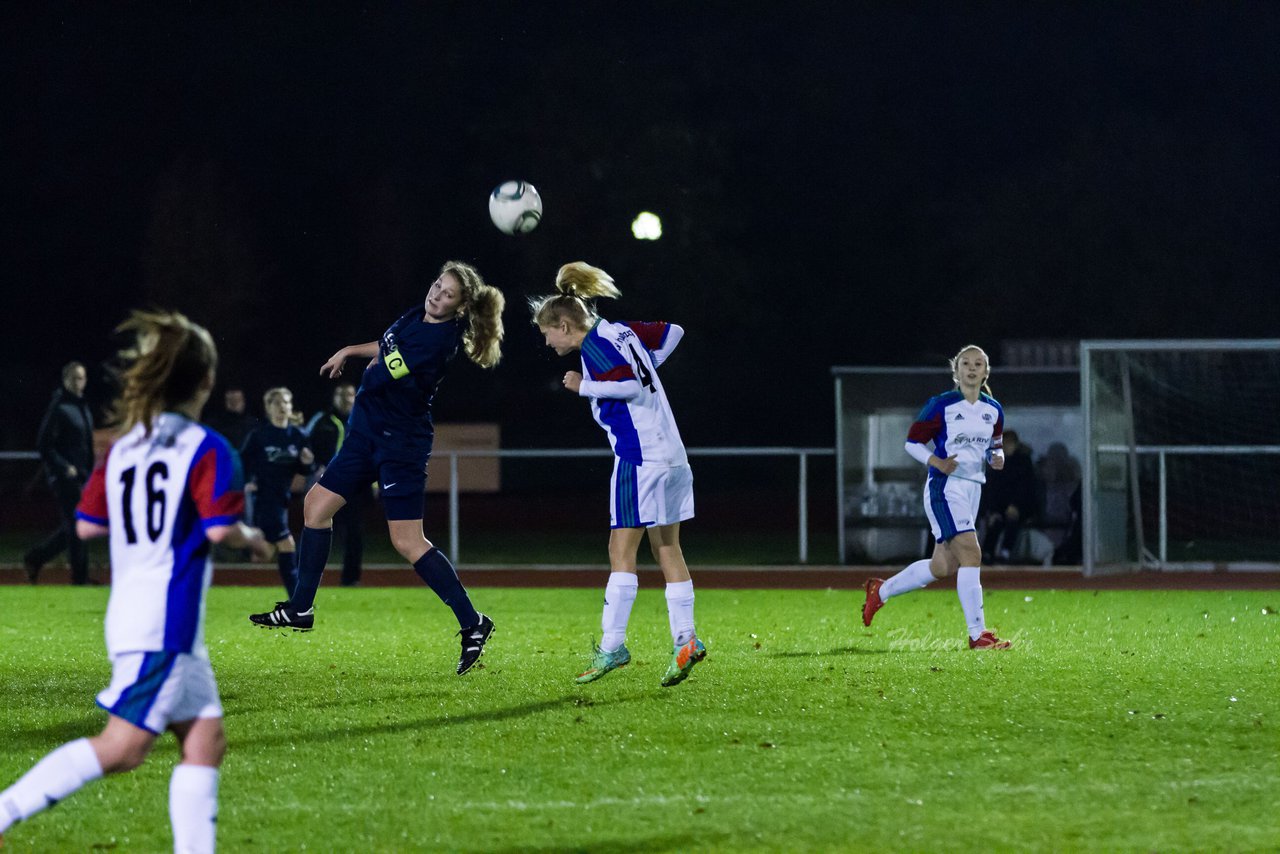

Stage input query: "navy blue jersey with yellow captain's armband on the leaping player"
[{"left": 349, "top": 306, "right": 462, "bottom": 453}]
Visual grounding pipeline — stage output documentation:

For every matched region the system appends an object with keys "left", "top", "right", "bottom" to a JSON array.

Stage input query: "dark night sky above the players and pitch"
[{"left": 0, "top": 3, "right": 1280, "bottom": 448}]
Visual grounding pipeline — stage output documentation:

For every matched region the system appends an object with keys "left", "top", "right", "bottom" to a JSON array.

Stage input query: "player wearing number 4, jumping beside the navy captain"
[{"left": 530, "top": 261, "right": 707, "bottom": 686}]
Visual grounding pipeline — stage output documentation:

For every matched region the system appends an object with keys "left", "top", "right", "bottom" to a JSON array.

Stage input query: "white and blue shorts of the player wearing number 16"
[{"left": 97, "top": 652, "right": 223, "bottom": 734}]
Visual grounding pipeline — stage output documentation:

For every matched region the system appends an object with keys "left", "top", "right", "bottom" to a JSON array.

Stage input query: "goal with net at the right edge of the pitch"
[{"left": 1080, "top": 341, "right": 1280, "bottom": 575}]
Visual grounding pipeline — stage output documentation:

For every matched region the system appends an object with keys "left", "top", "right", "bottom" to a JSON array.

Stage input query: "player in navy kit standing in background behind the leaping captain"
[{"left": 241, "top": 387, "right": 315, "bottom": 595}]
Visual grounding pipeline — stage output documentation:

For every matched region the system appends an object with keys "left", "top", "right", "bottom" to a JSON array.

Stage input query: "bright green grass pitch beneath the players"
[{"left": 0, "top": 588, "right": 1280, "bottom": 851}]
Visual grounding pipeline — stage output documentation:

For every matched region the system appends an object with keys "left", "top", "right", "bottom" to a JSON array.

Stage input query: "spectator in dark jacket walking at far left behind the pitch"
[{"left": 22, "top": 362, "right": 93, "bottom": 584}]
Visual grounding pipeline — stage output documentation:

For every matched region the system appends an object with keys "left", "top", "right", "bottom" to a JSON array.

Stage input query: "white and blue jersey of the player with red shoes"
[{"left": 906, "top": 392, "right": 1005, "bottom": 483}]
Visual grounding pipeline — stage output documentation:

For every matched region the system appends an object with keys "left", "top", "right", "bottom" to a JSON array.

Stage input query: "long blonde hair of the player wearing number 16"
[{"left": 111, "top": 310, "right": 218, "bottom": 435}]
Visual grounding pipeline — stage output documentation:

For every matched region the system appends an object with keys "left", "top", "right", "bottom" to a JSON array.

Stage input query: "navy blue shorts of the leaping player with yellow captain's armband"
[{"left": 317, "top": 433, "right": 431, "bottom": 521}]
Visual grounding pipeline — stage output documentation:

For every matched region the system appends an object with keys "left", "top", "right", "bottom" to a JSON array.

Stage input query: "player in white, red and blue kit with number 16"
[{"left": 0, "top": 312, "right": 271, "bottom": 851}]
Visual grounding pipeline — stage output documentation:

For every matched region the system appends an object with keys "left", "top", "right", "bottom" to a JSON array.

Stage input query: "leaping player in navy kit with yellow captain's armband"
[{"left": 250, "top": 261, "right": 504, "bottom": 676}]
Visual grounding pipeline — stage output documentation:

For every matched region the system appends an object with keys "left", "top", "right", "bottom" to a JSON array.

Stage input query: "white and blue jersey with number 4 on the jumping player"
[{"left": 579, "top": 318, "right": 689, "bottom": 466}]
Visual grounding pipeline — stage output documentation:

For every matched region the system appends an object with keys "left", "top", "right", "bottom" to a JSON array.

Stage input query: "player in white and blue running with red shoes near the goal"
[{"left": 863, "top": 344, "right": 1009, "bottom": 649}]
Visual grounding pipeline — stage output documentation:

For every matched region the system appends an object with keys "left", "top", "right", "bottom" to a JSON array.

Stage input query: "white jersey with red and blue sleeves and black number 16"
[{"left": 77, "top": 412, "right": 244, "bottom": 656}]
